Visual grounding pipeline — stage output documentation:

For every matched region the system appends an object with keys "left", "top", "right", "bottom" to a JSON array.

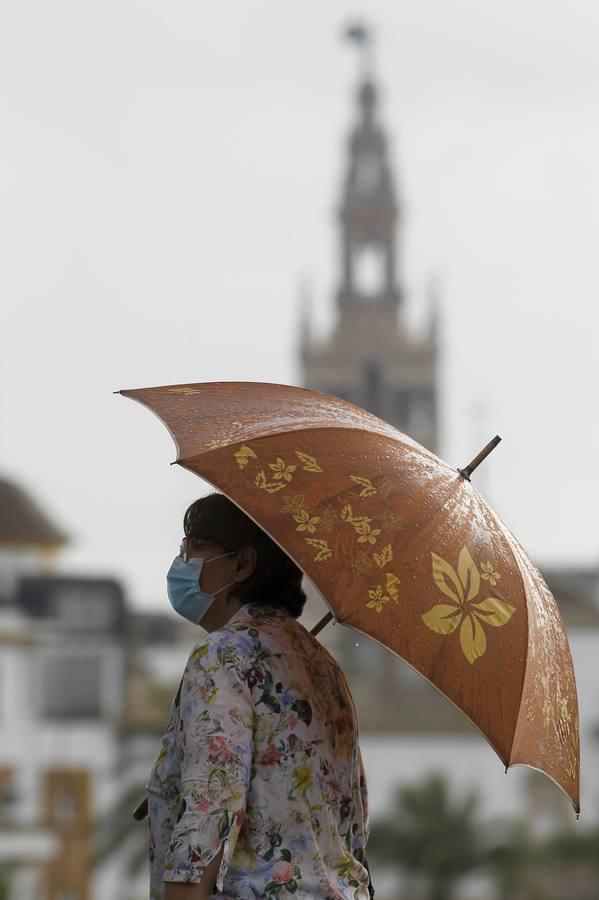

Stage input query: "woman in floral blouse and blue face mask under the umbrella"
[{"left": 146, "top": 494, "right": 370, "bottom": 900}]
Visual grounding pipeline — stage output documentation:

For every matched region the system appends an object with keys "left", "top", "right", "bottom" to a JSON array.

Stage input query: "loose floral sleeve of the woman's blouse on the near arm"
[{"left": 163, "top": 642, "right": 254, "bottom": 891}]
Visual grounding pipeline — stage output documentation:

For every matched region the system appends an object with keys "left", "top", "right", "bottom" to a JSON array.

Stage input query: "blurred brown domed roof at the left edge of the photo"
[{"left": 0, "top": 478, "right": 67, "bottom": 547}]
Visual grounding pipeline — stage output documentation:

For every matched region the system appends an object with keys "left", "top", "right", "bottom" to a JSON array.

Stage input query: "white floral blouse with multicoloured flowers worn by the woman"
[{"left": 146, "top": 604, "right": 369, "bottom": 900}]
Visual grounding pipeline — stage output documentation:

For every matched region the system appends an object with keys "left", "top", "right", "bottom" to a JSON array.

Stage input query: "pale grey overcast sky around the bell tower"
[{"left": 0, "top": 0, "right": 599, "bottom": 609}]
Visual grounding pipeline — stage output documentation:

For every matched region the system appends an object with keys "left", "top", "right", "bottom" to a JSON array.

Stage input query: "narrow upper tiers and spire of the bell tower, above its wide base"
[{"left": 338, "top": 26, "right": 400, "bottom": 309}]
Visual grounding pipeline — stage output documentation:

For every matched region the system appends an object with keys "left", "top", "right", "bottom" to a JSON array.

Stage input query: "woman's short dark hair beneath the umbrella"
[{"left": 183, "top": 493, "right": 306, "bottom": 619}]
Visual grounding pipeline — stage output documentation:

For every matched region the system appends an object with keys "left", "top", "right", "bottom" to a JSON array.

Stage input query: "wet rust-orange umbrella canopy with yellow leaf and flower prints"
[{"left": 120, "top": 382, "right": 579, "bottom": 812}]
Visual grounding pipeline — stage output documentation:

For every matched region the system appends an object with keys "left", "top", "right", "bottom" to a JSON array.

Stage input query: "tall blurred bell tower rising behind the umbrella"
[{"left": 300, "top": 25, "right": 438, "bottom": 451}]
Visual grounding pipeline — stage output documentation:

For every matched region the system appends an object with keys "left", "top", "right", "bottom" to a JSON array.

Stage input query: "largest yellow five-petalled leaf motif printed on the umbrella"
[{"left": 422, "top": 545, "right": 516, "bottom": 665}]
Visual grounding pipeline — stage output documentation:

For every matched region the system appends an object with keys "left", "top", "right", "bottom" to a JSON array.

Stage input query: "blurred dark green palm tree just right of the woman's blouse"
[{"left": 368, "top": 775, "right": 486, "bottom": 900}]
